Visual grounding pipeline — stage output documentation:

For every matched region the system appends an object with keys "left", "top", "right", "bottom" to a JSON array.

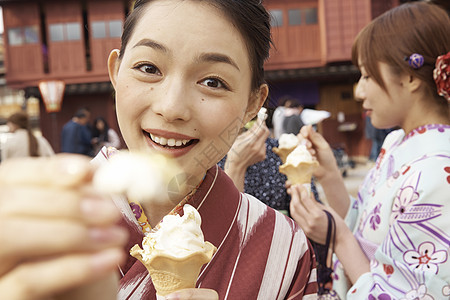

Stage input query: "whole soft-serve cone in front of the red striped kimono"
[{"left": 130, "top": 204, "right": 217, "bottom": 296}]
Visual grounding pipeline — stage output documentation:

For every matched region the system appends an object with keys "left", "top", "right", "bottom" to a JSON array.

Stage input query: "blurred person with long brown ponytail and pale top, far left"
[{"left": 1, "top": 112, "right": 55, "bottom": 161}]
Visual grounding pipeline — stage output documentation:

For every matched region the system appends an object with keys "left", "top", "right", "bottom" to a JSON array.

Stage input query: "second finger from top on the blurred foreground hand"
[{"left": 0, "top": 186, "right": 121, "bottom": 226}]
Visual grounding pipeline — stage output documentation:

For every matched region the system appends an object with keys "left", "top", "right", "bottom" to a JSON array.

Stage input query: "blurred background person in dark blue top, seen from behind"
[{"left": 61, "top": 108, "right": 93, "bottom": 156}]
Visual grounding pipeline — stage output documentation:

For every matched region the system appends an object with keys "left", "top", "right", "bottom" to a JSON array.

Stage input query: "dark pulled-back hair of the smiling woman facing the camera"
[{"left": 119, "top": 0, "right": 272, "bottom": 91}]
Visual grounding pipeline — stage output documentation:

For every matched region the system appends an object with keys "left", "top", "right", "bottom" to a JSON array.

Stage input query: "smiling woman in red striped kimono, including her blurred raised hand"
[{"left": 0, "top": 0, "right": 317, "bottom": 299}]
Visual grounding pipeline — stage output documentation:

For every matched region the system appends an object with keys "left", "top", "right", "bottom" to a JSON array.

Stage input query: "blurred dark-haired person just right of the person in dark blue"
[{"left": 92, "top": 117, "right": 121, "bottom": 154}]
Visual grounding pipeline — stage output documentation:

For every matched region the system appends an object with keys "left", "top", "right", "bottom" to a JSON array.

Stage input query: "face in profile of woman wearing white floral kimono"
[{"left": 355, "top": 62, "right": 411, "bottom": 129}]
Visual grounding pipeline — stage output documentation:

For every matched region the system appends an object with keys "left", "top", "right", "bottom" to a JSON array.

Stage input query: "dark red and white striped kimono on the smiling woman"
[{"left": 92, "top": 149, "right": 317, "bottom": 300}]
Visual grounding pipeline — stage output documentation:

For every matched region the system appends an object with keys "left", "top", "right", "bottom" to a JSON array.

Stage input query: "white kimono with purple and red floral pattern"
[{"left": 334, "top": 124, "right": 450, "bottom": 300}]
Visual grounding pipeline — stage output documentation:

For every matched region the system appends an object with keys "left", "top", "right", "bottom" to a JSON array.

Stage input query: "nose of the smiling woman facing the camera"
[{"left": 152, "top": 80, "right": 190, "bottom": 122}]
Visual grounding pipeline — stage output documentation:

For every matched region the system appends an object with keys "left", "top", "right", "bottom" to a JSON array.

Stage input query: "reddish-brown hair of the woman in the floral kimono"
[{"left": 352, "top": 2, "right": 450, "bottom": 105}]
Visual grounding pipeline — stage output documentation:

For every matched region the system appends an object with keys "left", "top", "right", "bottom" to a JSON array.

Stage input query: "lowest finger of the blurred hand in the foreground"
[{"left": 0, "top": 249, "right": 125, "bottom": 300}]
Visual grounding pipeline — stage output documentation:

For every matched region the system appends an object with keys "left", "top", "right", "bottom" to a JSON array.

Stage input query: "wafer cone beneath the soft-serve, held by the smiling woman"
[{"left": 130, "top": 242, "right": 217, "bottom": 296}]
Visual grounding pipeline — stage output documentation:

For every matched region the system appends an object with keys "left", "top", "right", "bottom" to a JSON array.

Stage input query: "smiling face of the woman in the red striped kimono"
[{"left": 109, "top": 0, "right": 267, "bottom": 183}]
